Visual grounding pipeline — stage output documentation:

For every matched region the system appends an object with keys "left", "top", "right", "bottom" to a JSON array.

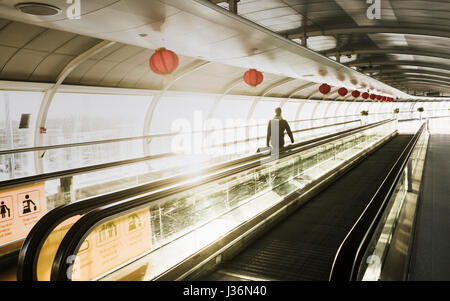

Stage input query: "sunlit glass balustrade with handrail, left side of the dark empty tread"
[{"left": 19, "top": 120, "right": 414, "bottom": 280}]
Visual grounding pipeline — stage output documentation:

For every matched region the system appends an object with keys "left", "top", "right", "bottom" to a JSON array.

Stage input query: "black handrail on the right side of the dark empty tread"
[{"left": 329, "top": 123, "right": 425, "bottom": 281}]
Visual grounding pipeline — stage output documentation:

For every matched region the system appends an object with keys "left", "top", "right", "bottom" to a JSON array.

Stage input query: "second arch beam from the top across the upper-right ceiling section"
[{"left": 322, "top": 48, "right": 450, "bottom": 59}]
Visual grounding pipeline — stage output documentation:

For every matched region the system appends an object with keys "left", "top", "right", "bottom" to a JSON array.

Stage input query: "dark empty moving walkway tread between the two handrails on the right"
[{"left": 204, "top": 135, "right": 413, "bottom": 281}]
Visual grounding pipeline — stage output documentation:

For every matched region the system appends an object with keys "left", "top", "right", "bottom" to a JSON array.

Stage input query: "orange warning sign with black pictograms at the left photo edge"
[{"left": 0, "top": 183, "right": 47, "bottom": 245}]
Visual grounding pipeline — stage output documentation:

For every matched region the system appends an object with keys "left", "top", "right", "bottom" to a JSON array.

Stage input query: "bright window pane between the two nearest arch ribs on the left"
[{"left": 44, "top": 93, "right": 152, "bottom": 145}]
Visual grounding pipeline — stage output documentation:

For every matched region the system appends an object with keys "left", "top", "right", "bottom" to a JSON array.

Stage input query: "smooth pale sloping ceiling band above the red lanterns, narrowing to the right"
[{"left": 0, "top": 0, "right": 407, "bottom": 97}]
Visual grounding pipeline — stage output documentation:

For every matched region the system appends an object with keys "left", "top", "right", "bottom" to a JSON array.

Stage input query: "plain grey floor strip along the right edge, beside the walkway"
[{"left": 409, "top": 134, "right": 450, "bottom": 281}]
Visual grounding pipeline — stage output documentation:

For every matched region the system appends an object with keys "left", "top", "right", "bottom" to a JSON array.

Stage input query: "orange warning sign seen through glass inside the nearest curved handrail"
[{"left": 72, "top": 209, "right": 151, "bottom": 280}]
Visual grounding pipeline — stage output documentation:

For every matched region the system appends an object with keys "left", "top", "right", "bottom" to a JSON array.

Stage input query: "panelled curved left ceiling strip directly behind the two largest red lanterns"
[{"left": 0, "top": 19, "right": 318, "bottom": 98}]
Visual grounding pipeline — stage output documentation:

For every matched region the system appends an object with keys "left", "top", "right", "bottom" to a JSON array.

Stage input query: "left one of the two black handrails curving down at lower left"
[{"left": 17, "top": 120, "right": 380, "bottom": 281}]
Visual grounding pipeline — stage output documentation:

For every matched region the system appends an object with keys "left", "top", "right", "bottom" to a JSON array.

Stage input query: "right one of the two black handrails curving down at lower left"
[{"left": 51, "top": 119, "right": 392, "bottom": 281}]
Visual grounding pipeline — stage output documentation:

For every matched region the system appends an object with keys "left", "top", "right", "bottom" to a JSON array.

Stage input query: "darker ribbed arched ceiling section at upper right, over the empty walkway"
[{"left": 237, "top": 0, "right": 450, "bottom": 95}]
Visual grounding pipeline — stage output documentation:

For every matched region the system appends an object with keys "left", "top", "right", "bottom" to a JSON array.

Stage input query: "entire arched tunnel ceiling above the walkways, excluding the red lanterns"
[{"left": 0, "top": 0, "right": 450, "bottom": 99}]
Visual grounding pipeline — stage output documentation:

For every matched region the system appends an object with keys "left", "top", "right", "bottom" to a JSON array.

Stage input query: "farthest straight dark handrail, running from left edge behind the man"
[{"left": 0, "top": 119, "right": 360, "bottom": 189}]
